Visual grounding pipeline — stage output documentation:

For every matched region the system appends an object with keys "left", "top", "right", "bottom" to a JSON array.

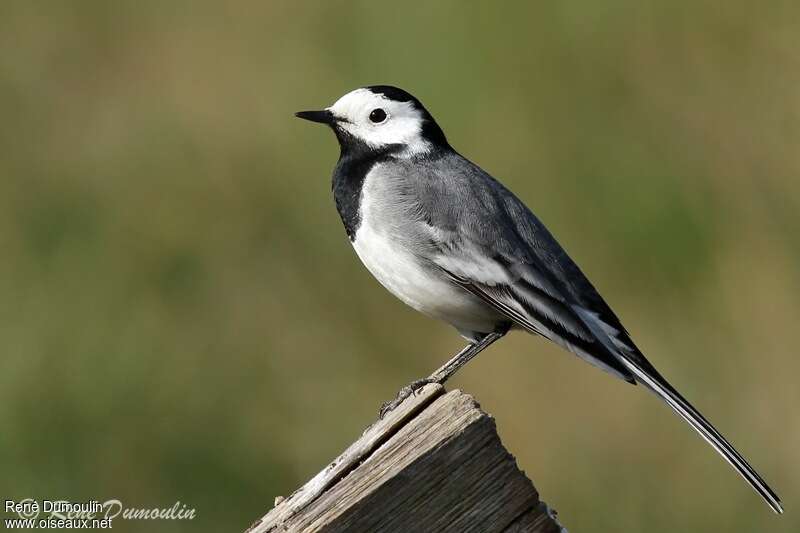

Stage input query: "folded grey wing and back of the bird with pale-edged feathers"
[{"left": 418, "top": 156, "right": 652, "bottom": 383}]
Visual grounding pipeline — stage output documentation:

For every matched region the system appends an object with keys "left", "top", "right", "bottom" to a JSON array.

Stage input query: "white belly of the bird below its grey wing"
[{"left": 353, "top": 219, "right": 499, "bottom": 333}]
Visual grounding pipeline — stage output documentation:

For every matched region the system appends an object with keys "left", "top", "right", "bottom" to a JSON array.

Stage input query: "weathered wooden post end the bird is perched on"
[{"left": 247, "top": 385, "right": 566, "bottom": 533}]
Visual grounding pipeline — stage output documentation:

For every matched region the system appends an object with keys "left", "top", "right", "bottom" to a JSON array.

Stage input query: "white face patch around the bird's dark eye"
[{"left": 328, "top": 89, "right": 431, "bottom": 154}]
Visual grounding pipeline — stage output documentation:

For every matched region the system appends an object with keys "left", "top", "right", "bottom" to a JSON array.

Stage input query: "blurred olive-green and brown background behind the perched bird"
[{"left": 0, "top": 0, "right": 800, "bottom": 532}]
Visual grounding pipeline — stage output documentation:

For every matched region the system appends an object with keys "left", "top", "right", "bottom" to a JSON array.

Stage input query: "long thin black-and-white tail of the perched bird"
[{"left": 620, "top": 355, "right": 783, "bottom": 514}]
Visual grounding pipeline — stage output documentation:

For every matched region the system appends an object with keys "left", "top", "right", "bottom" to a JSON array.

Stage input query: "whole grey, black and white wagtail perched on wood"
[{"left": 295, "top": 85, "right": 783, "bottom": 513}]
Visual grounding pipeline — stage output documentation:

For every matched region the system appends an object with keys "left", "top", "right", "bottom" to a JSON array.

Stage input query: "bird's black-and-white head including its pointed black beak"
[{"left": 296, "top": 85, "right": 448, "bottom": 156}]
